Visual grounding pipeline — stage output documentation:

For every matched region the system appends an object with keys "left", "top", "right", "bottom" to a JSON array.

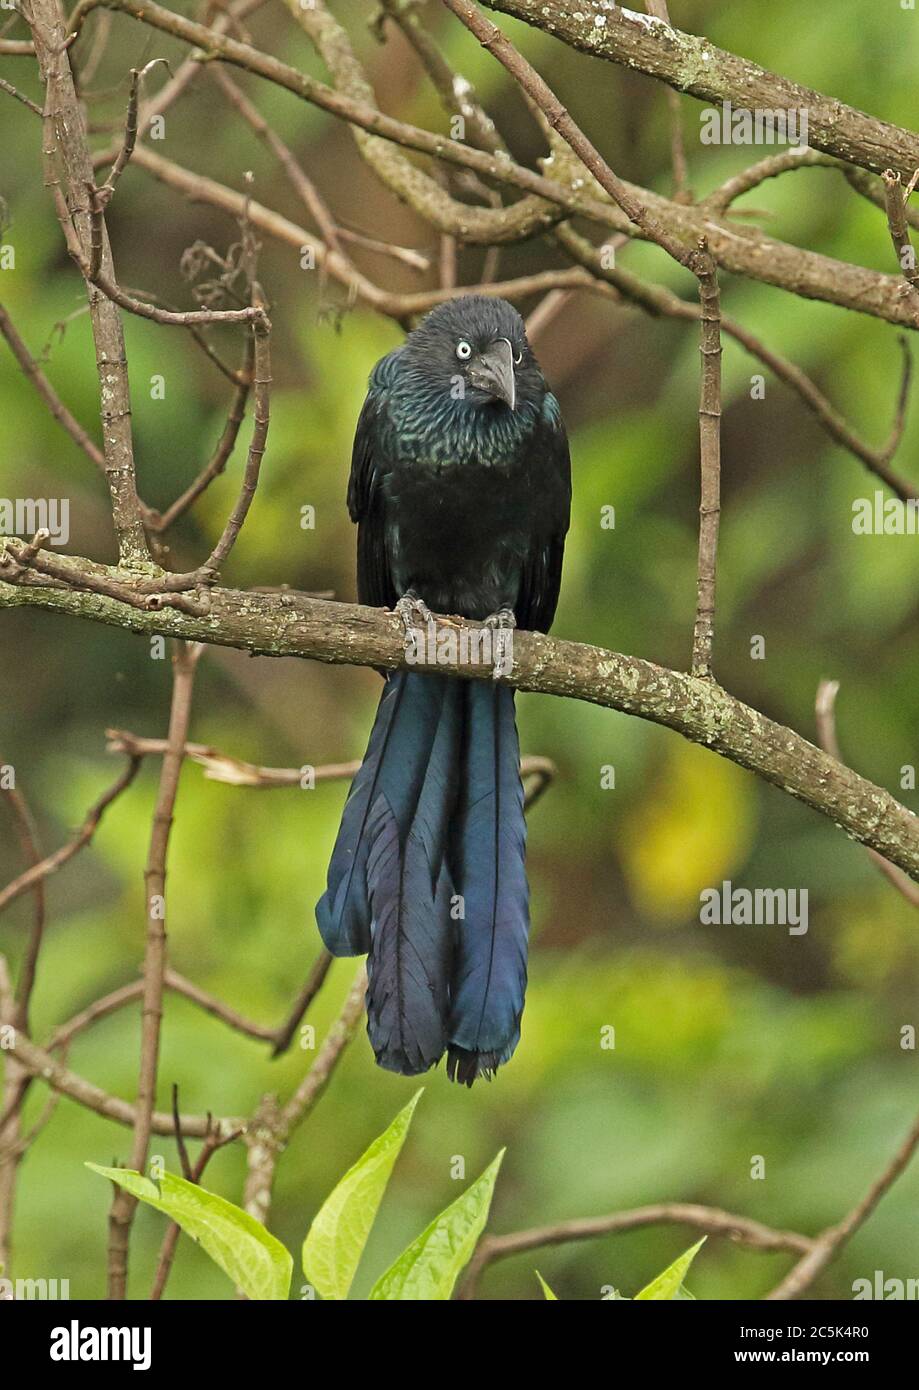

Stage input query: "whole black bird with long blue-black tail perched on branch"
[{"left": 316, "top": 295, "right": 571, "bottom": 1086}]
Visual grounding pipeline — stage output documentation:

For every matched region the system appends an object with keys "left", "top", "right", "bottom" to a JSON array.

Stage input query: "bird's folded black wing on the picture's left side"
[{"left": 348, "top": 353, "right": 399, "bottom": 607}]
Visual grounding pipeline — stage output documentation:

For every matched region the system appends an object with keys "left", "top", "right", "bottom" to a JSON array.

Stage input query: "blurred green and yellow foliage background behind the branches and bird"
[{"left": 0, "top": 0, "right": 919, "bottom": 1300}]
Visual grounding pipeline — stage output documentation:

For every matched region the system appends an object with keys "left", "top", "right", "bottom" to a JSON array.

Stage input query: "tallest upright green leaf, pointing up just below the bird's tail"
[{"left": 303, "top": 1091, "right": 421, "bottom": 1298}]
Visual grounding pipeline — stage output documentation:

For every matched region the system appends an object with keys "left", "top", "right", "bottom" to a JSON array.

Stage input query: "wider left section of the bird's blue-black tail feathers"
[{"left": 316, "top": 671, "right": 463, "bottom": 1076}]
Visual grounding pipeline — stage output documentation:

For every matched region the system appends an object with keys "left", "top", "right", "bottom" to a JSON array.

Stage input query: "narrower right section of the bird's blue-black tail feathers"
[{"left": 446, "top": 681, "right": 530, "bottom": 1086}]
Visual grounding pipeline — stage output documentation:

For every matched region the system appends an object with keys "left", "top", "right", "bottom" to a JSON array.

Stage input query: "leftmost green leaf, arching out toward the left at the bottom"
[{"left": 86, "top": 1163, "right": 293, "bottom": 1300}]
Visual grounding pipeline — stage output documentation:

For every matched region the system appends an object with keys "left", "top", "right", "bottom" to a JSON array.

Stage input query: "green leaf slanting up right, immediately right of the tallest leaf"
[{"left": 370, "top": 1148, "right": 505, "bottom": 1302}]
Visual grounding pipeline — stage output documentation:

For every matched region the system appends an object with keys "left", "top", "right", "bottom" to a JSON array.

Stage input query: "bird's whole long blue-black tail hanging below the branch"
[{"left": 316, "top": 671, "right": 528, "bottom": 1086}]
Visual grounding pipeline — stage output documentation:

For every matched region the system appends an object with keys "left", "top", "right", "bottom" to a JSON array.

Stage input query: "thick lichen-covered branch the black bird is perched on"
[{"left": 0, "top": 541, "right": 919, "bottom": 881}]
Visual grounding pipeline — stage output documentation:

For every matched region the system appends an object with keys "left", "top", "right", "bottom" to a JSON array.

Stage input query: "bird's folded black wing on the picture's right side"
[{"left": 517, "top": 393, "right": 571, "bottom": 632}]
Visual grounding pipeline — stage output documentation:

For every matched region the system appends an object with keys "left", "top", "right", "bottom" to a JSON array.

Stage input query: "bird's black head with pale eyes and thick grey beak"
[{"left": 405, "top": 295, "right": 546, "bottom": 411}]
